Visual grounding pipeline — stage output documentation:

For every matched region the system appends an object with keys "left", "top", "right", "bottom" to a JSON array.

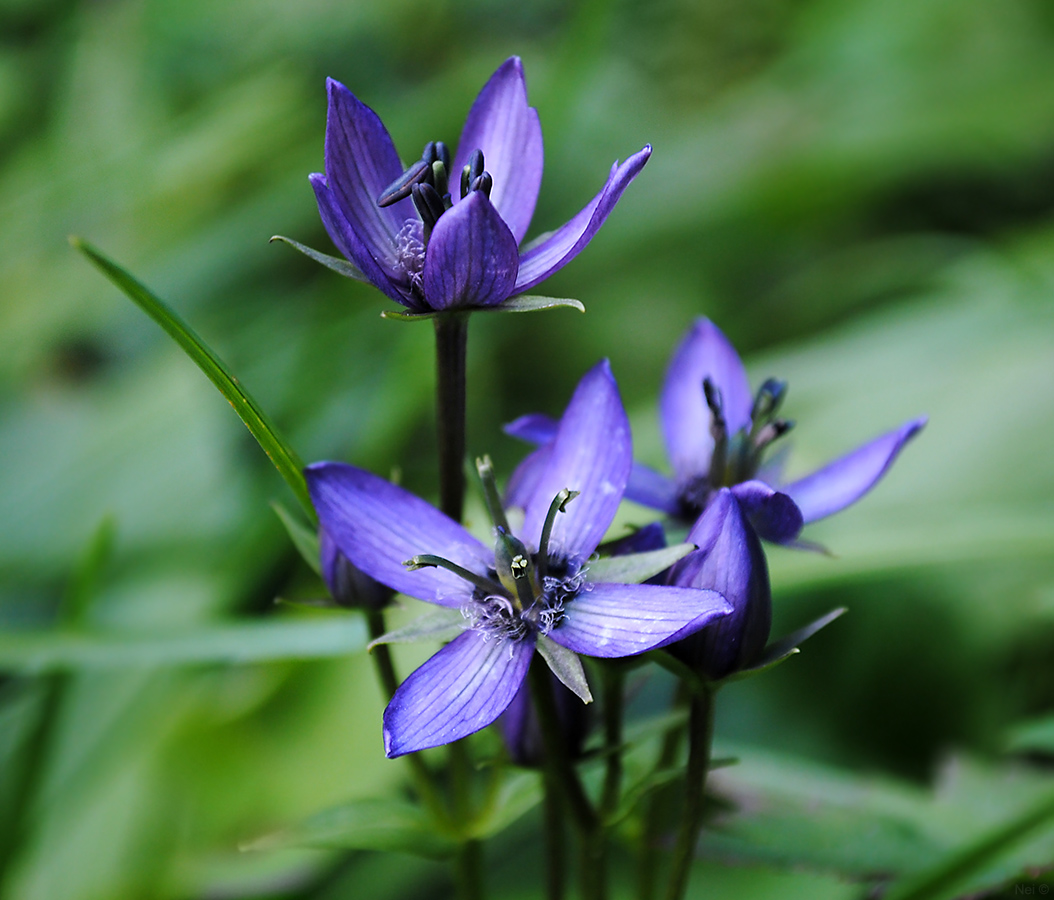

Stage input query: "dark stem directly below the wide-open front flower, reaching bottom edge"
[{"left": 528, "top": 660, "right": 607, "bottom": 900}]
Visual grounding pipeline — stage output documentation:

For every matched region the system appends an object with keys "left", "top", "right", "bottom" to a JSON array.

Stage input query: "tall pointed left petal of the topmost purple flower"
[{"left": 326, "top": 78, "right": 416, "bottom": 275}]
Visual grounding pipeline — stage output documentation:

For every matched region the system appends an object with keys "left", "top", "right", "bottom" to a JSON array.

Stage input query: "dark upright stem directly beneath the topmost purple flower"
[{"left": 434, "top": 312, "right": 468, "bottom": 522}]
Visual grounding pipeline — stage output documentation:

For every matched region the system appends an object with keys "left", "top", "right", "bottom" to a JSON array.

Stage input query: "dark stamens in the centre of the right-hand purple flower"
[{"left": 678, "top": 377, "right": 794, "bottom": 520}]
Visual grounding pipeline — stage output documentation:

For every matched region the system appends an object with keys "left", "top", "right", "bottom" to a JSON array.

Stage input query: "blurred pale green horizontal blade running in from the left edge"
[{"left": 0, "top": 615, "right": 367, "bottom": 673}]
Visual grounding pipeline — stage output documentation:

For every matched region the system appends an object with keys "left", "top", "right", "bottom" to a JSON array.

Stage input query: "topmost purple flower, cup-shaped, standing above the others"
[{"left": 311, "top": 57, "right": 651, "bottom": 312}]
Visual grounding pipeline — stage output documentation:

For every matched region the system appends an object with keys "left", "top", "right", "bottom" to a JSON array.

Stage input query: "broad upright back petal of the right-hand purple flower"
[{"left": 659, "top": 318, "right": 754, "bottom": 481}]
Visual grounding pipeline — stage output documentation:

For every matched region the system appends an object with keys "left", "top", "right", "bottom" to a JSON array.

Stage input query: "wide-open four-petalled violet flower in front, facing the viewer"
[{"left": 306, "top": 361, "right": 729, "bottom": 757}]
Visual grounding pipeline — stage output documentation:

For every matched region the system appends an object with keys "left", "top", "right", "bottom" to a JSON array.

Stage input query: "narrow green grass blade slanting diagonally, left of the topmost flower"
[{"left": 70, "top": 237, "right": 315, "bottom": 522}]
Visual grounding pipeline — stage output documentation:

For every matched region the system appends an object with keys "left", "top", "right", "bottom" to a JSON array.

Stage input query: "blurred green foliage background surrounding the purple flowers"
[{"left": 0, "top": 0, "right": 1054, "bottom": 900}]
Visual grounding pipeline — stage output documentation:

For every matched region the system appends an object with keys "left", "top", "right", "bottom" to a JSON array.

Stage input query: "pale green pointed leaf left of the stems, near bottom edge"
[{"left": 242, "top": 798, "right": 456, "bottom": 859}]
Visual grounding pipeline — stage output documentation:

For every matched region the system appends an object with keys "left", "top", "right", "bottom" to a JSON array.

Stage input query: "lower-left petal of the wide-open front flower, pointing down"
[{"left": 384, "top": 631, "right": 534, "bottom": 758}]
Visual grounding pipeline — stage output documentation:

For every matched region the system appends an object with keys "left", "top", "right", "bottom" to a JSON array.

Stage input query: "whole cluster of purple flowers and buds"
[{"left": 300, "top": 58, "right": 924, "bottom": 760}]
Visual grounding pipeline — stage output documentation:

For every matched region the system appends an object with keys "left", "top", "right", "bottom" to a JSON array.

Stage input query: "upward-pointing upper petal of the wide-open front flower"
[{"left": 521, "top": 359, "right": 633, "bottom": 560}]
